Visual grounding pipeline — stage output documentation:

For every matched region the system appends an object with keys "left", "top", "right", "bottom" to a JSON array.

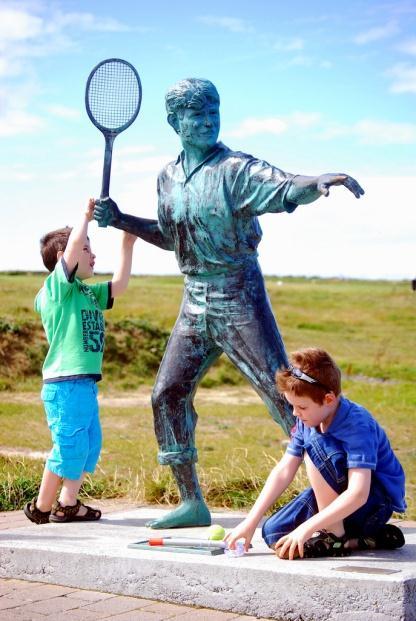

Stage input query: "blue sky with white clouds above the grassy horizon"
[{"left": 0, "top": 0, "right": 416, "bottom": 279}]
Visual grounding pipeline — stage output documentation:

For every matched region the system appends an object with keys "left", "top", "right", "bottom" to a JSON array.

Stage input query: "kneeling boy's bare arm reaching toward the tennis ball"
[{"left": 225, "top": 453, "right": 302, "bottom": 552}]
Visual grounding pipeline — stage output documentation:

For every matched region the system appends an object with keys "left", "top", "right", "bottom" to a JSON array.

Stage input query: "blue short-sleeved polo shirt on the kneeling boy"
[{"left": 287, "top": 397, "right": 406, "bottom": 513}]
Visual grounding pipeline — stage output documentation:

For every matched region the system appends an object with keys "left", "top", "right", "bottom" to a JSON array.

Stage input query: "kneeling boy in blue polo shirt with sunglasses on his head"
[{"left": 226, "top": 348, "right": 406, "bottom": 560}]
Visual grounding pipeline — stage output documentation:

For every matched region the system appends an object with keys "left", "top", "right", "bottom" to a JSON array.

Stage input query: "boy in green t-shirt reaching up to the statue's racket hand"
[{"left": 24, "top": 199, "right": 137, "bottom": 524}]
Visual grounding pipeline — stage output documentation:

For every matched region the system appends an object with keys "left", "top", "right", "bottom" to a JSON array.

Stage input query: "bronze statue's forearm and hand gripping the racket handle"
[{"left": 94, "top": 198, "right": 173, "bottom": 250}]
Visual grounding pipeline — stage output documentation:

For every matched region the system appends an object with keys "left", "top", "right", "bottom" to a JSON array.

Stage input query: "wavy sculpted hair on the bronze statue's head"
[{"left": 165, "top": 78, "right": 220, "bottom": 125}]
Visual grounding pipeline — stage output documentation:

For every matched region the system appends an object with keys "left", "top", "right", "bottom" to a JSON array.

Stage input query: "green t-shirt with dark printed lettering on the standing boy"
[{"left": 35, "top": 259, "right": 113, "bottom": 381}]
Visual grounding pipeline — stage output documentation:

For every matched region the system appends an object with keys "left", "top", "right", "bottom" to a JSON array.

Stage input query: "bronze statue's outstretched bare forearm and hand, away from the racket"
[{"left": 286, "top": 173, "right": 364, "bottom": 205}]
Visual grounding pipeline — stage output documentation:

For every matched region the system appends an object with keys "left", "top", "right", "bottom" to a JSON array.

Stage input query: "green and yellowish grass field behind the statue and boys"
[{"left": 0, "top": 274, "right": 416, "bottom": 519}]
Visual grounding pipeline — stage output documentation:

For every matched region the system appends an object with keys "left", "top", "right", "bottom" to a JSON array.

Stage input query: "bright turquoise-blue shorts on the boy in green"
[{"left": 41, "top": 378, "right": 102, "bottom": 480}]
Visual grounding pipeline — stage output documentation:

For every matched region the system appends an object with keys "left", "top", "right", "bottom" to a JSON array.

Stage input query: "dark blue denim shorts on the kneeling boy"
[{"left": 262, "top": 434, "right": 393, "bottom": 546}]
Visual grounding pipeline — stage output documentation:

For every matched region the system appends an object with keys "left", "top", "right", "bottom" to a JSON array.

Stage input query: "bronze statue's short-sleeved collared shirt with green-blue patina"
[{"left": 158, "top": 143, "right": 297, "bottom": 276}]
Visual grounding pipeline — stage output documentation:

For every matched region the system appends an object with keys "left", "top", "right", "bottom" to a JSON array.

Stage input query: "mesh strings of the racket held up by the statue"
[{"left": 88, "top": 61, "right": 141, "bottom": 130}]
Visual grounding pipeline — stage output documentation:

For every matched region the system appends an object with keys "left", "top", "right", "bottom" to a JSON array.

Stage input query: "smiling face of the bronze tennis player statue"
[{"left": 177, "top": 102, "right": 220, "bottom": 149}]
